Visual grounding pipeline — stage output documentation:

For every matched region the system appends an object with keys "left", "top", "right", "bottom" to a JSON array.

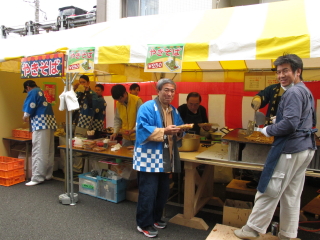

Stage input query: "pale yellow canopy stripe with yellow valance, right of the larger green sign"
[{"left": 183, "top": 8, "right": 234, "bottom": 62}]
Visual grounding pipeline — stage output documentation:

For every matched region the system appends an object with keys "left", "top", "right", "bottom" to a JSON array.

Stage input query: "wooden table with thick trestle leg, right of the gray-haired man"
[{"left": 170, "top": 144, "right": 320, "bottom": 230}]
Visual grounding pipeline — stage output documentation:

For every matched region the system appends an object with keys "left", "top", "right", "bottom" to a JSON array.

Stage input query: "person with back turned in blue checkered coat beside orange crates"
[{"left": 23, "top": 80, "right": 56, "bottom": 186}]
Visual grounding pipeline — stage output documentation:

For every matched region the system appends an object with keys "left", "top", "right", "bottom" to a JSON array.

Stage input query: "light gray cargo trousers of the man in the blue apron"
[{"left": 247, "top": 149, "right": 315, "bottom": 238}]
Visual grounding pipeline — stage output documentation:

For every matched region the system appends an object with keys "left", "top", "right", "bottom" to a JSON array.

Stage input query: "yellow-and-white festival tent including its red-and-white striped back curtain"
[{"left": 0, "top": 0, "right": 320, "bottom": 154}]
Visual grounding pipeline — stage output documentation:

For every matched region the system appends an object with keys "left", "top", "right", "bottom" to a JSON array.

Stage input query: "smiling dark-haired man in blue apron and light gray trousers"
[{"left": 234, "top": 54, "right": 317, "bottom": 240}]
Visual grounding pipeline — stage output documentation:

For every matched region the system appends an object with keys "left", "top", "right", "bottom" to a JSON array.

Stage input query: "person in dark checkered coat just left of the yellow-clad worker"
[{"left": 92, "top": 84, "right": 107, "bottom": 138}]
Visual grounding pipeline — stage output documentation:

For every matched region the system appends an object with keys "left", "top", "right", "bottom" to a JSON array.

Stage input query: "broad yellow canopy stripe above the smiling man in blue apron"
[{"left": 256, "top": 1, "right": 310, "bottom": 59}]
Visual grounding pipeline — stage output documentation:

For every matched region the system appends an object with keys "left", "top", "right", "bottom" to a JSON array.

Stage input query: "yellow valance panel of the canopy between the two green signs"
[{"left": 98, "top": 45, "right": 130, "bottom": 64}]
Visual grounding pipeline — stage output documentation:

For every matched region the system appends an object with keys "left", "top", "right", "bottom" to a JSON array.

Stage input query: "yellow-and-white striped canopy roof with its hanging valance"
[{"left": 0, "top": 0, "right": 320, "bottom": 71}]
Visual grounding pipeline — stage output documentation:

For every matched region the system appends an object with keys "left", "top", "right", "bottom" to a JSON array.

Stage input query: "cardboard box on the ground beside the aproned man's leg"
[{"left": 222, "top": 199, "right": 252, "bottom": 228}]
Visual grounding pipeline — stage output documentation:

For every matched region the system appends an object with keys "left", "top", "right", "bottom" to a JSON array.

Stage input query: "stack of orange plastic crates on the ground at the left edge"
[{"left": 0, "top": 156, "right": 25, "bottom": 187}]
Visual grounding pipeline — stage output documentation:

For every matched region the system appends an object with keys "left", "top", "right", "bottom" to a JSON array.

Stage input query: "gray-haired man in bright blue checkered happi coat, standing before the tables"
[{"left": 133, "top": 79, "right": 188, "bottom": 237}]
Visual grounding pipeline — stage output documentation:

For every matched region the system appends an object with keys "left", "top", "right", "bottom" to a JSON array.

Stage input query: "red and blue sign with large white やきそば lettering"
[{"left": 20, "top": 53, "right": 64, "bottom": 78}]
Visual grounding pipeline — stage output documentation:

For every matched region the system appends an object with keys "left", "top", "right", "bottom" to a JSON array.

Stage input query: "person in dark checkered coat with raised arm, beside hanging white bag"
[{"left": 74, "top": 75, "right": 98, "bottom": 137}]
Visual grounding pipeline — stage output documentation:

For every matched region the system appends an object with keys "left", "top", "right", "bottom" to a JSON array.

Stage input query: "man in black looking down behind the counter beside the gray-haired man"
[{"left": 178, "top": 92, "right": 211, "bottom": 136}]
